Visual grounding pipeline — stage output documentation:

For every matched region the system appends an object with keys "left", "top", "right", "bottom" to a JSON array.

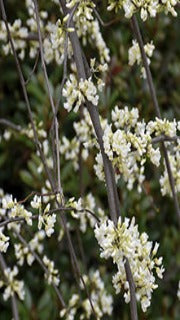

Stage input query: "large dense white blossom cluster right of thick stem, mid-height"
[{"left": 102, "top": 106, "right": 160, "bottom": 192}]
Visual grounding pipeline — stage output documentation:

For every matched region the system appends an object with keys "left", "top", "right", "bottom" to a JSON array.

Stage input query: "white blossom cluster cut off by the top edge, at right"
[{"left": 107, "top": 0, "right": 177, "bottom": 21}]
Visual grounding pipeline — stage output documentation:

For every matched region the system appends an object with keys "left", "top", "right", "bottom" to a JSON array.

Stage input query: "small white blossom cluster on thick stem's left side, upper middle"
[{"left": 62, "top": 74, "right": 99, "bottom": 112}]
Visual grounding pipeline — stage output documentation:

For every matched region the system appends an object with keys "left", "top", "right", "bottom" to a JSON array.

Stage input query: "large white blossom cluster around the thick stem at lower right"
[{"left": 95, "top": 218, "right": 164, "bottom": 312}]
